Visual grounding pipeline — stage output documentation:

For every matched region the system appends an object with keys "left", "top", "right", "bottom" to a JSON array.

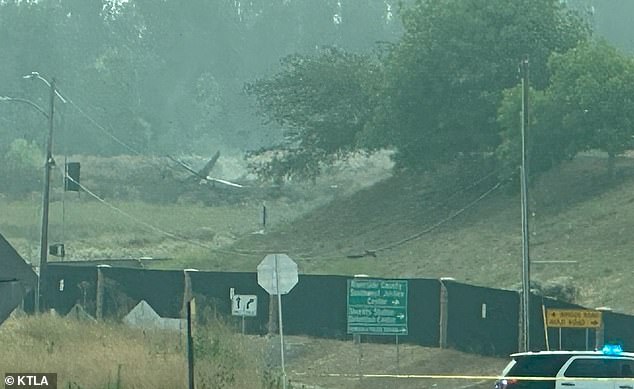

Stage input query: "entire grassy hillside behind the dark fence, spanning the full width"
[{"left": 0, "top": 155, "right": 634, "bottom": 313}]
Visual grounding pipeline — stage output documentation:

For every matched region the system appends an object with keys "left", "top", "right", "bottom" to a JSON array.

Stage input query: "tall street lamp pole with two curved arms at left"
[{"left": 0, "top": 72, "right": 66, "bottom": 312}]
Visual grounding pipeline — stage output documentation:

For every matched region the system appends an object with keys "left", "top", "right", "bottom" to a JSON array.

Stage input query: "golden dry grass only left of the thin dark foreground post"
[{"left": 0, "top": 315, "right": 186, "bottom": 388}]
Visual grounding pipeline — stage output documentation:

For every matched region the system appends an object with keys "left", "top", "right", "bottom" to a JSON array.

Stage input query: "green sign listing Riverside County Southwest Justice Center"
[{"left": 348, "top": 278, "right": 407, "bottom": 335}]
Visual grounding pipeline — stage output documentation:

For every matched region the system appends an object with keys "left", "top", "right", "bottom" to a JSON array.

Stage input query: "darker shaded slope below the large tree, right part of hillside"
[{"left": 175, "top": 156, "right": 634, "bottom": 312}]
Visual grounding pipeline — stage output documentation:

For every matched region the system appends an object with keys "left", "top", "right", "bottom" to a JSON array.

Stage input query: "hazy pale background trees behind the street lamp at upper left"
[{"left": 0, "top": 0, "right": 401, "bottom": 155}]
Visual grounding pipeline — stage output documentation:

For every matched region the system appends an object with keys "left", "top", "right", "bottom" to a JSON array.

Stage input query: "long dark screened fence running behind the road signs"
[{"left": 40, "top": 265, "right": 634, "bottom": 356}]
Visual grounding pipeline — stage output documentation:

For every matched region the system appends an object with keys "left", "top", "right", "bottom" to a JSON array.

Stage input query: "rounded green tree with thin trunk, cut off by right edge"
[{"left": 548, "top": 41, "right": 634, "bottom": 176}]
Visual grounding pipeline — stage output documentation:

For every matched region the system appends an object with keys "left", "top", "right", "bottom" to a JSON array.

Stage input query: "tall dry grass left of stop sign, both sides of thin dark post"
[{"left": 0, "top": 314, "right": 264, "bottom": 389}]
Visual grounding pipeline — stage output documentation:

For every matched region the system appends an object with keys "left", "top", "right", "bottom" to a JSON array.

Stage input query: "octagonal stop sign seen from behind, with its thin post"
[{"left": 258, "top": 254, "right": 299, "bottom": 389}]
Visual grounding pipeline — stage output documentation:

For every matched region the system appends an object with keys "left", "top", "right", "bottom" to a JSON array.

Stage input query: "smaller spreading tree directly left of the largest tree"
[{"left": 246, "top": 48, "right": 380, "bottom": 178}]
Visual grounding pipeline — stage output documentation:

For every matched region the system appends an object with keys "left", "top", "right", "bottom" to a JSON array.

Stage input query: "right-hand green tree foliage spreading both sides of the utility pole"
[{"left": 496, "top": 41, "right": 634, "bottom": 180}]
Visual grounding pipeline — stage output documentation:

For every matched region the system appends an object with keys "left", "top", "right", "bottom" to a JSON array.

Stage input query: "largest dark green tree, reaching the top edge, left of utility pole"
[{"left": 365, "top": 0, "right": 589, "bottom": 169}]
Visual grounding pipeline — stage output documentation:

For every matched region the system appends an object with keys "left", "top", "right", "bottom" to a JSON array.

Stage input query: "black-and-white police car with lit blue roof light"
[{"left": 495, "top": 345, "right": 634, "bottom": 389}]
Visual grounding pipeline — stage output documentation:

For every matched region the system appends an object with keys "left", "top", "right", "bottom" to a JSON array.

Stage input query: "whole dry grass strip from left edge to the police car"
[{"left": 0, "top": 314, "right": 507, "bottom": 389}]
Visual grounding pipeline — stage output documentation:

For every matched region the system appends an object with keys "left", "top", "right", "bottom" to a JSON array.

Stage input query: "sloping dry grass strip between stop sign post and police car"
[{"left": 287, "top": 337, "right": 508, "bottom": 389}]
